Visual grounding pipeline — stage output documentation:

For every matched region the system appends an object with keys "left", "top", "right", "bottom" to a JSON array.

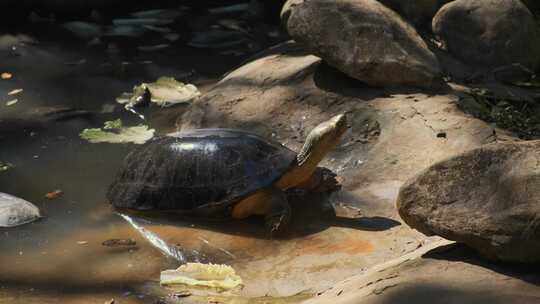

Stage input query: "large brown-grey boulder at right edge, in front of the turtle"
[{"left": 397, "top": 141, "right": 540, "bottom": 262}]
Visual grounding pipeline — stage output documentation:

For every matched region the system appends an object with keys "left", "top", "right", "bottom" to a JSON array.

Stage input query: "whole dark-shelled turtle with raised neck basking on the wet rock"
[{"left": 107, "top": 114, "right": 347, "bottom": 233}]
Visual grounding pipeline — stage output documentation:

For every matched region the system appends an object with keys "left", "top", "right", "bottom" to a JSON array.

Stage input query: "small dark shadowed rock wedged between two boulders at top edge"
[{"left": 379, "top": 0, "right": 451, "bottom": 27}]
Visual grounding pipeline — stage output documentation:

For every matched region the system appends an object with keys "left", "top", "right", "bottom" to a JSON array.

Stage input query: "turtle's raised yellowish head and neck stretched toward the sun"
[{"left": 298, "top": 114, "right": 347, "bottom": 166}]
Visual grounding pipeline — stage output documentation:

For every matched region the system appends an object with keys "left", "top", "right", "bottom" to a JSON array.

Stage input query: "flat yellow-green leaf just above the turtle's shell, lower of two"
[{"left": 79, "top": 119, "right": 155, "bottom": 144}]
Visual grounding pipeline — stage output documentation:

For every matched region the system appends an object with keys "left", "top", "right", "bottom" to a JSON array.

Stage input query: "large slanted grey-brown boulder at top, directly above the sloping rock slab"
[{"left": 282, "top": 0, "right": 441, "bottom": 88}]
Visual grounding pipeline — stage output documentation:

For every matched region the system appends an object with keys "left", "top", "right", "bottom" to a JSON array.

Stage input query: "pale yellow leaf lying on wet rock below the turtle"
[{"left": 160, "top": 263, "right": 243, "bottom": 291}]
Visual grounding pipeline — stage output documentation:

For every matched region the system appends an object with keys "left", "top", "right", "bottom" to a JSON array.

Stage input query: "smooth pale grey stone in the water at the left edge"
[{"left": 0, "top": 192, "right": 41, "bottom": 227}]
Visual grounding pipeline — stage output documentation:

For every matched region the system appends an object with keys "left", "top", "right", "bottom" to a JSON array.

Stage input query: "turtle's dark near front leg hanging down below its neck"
[{"left": 265, "top": 188, "right": 291, "bottom": 236}]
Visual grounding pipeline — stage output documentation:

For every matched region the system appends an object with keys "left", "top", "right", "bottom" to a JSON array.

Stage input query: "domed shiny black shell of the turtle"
[{"left": 107, "top": 129, "right": 296, "bottom": 216}]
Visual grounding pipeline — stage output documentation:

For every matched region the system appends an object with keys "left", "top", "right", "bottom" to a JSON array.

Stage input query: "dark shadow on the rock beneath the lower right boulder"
[{"left": 422, "top": 243, "right": 540, "bottom": 284}]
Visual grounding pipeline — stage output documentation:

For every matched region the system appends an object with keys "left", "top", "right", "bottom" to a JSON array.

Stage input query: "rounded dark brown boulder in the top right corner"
[{"left": 433, "top": 0, "right": 540, "bottom": 69}]
